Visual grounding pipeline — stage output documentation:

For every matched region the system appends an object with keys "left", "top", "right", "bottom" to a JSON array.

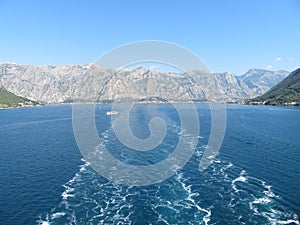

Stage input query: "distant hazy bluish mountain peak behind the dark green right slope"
[{"left": 237, "top": 69, "right": 290, "bottom": 95}]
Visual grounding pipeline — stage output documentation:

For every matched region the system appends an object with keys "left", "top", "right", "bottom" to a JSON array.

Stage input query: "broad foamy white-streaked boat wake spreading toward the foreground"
[{"left": 37, "top": 117, "right": 299, "bottom": 225}]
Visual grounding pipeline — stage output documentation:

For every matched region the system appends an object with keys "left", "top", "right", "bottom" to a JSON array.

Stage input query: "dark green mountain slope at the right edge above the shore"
[{"left": 250, "top": 68, "right": 300, "bottom": 105}]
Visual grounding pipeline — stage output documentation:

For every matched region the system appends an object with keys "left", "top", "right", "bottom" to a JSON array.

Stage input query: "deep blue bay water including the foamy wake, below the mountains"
[{"left": 0, "top": 105, "right": 300, "bottom": 224}]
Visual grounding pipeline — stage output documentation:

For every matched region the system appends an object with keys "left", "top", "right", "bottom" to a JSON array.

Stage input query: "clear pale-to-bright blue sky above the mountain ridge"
[{"left": 0, "top": 0, "right": 300, "bottom": 74}]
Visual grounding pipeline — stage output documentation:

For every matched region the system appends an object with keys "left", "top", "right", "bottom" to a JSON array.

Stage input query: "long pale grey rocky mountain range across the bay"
[{"left": 0, "top": 63, "right": 288, "bottom": 103}]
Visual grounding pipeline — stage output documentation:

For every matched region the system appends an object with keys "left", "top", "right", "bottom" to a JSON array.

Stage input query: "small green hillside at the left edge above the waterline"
[{"left": 0, "top": 86, "right": 39, "bottom": 108}]
